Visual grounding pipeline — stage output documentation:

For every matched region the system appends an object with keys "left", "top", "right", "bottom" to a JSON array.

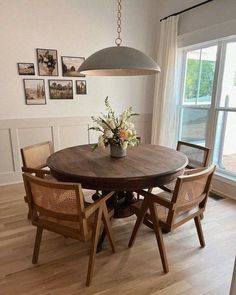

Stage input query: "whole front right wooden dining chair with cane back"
[{"left": 129, "top": 165, "right": 215, "bottom": 273}]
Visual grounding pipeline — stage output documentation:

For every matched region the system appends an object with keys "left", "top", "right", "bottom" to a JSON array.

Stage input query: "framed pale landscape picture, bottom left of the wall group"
[{"left": 23, "top": 79, "right": 46, "bottom": 105}]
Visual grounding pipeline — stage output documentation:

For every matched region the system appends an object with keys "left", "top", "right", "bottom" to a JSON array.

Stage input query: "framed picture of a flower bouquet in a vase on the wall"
[{"left": 36, "top": 49, "right": 58, "bottom": 76}]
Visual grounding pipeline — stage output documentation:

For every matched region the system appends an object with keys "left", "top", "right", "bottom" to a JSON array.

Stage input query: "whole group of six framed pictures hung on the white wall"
[{"left": 17, "top": 48, "right": 87, "bottom": 105}]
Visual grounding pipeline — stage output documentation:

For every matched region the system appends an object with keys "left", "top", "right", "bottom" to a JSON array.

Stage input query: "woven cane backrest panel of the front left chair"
[{"left": 30, "top": 183, "right": 78, "bottom": 215}]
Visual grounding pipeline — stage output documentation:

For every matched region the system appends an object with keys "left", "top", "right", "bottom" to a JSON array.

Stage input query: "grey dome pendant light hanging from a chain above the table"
[{"left": 79, "top": 0, "right": 160, "bottom": 76}]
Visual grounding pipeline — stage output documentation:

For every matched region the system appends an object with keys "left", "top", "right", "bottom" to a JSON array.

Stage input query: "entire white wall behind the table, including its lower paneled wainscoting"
[{"left": 0, "top": 0, "right": 159, "bottom": 185}]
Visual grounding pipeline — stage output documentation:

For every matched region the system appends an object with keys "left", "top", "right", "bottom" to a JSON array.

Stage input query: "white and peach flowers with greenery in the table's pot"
[{"left": 89, "top": 97, "right": 139, "bottom": 150}]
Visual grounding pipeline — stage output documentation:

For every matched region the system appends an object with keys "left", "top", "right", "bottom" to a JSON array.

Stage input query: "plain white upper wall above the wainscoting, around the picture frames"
[{"left": 0, "top": 0, "right": 159, "bottom": 119}]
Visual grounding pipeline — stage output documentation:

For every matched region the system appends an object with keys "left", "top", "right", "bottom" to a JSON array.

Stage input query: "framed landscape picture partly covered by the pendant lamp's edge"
[{"left": 61, "top": 56, "right": 85, "bottom": 77}]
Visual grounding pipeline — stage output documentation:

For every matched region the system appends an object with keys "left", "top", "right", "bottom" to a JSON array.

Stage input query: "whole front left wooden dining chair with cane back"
[{"left": 23, "top": 173, "right": 115, "bottom": 286}]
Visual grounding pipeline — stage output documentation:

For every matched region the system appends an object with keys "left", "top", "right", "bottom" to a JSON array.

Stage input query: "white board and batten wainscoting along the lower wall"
[{"left": 0, "top": 114, "right": 152, "bottom": 185}]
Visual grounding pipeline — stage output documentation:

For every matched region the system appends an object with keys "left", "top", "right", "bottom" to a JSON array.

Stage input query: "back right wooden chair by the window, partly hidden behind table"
[{"left": 159, "top": 141, "right": 211, "bottom": 192}]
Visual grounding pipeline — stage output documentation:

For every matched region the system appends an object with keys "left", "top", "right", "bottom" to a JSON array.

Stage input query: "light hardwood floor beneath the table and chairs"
[{"left": 0, "top": 184, "right": 236, "bottom": 295}]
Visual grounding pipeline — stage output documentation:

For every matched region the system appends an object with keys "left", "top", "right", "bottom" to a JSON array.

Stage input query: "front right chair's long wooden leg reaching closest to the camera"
[{"left": 149, "top": 202, "right": 169, "bottom": 273}]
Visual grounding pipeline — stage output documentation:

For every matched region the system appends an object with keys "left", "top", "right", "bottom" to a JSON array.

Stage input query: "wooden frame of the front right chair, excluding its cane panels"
[{"left": 129, "top": 165, "right": 215, "bottom": 273}]
